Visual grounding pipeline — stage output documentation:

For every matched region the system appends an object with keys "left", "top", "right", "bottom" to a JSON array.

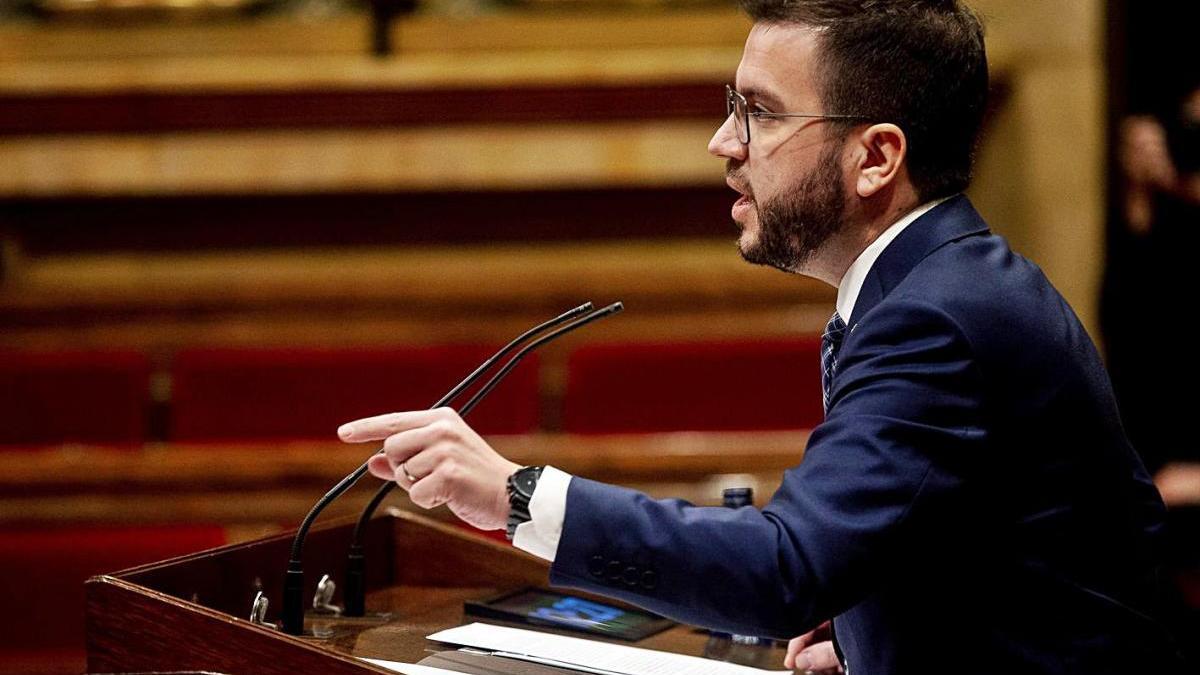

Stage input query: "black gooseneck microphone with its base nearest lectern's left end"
[{"left": 282, "top": 303, "right": 620, "bottom": 635}]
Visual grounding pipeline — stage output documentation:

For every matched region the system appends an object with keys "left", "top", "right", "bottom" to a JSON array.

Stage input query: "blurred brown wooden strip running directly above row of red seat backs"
[{"left": 0, "top": 305, "right": 833, "bottom": 355}]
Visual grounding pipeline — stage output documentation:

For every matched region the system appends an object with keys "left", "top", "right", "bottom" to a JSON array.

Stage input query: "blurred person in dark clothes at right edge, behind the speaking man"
[{"left": 1102, "top": 81, "right": 1200, "bottom": 667}]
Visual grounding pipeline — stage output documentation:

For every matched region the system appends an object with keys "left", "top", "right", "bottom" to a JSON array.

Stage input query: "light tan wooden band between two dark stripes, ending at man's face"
[{"left": 0, "top": 118, "right": 724, "bottom": 197}]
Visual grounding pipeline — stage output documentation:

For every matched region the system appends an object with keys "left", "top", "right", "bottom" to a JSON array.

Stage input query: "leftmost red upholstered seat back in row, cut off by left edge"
[{"left": 0, "top": 351, "right": 150, "bottom": 446}]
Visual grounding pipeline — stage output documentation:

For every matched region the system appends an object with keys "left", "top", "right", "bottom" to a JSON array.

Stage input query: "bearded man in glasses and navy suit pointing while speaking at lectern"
[{"left": 340, "top": 0, "right": 1174, "bottom": 675}]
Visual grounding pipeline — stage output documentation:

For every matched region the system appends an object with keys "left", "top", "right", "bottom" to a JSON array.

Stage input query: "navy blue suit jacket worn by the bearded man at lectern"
[{"left": 551, "top": 197, "right": 1175, "bottom": 675}]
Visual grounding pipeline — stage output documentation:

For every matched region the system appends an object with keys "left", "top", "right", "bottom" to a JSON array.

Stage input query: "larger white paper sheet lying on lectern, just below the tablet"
[{"left": 430, "top": 623, "right": 792, "bottom": 675}]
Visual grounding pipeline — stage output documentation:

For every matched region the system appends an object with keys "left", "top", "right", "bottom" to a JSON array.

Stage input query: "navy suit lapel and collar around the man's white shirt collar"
[{"left": 846, "top": 195, "right": 988, "bottom": 329}]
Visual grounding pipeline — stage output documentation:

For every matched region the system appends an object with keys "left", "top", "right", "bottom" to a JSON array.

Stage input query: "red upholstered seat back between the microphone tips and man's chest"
[{"left": 563, "top": 336, "right": 823, "bottom": 434}]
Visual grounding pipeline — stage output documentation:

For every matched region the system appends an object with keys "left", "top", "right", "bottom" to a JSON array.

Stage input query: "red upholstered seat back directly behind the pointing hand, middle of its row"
[{"left": 170, "top": 346, "right": 539, "bottom": 441}]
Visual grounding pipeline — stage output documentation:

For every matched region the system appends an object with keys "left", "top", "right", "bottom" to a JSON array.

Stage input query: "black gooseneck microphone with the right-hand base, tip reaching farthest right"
[{"left": 342, "top": 303, "right": 624, "bottom": 616}]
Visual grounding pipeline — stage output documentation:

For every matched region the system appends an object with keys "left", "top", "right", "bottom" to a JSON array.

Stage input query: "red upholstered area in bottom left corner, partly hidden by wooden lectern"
[{"left": 0, "top": 525, "right": 227, "bottom": 673}]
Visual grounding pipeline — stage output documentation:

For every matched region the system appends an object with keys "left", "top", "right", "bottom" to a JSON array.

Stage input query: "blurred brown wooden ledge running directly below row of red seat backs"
[{"left": 0, "top": 431, "right": 808, "bottom": 492}]
